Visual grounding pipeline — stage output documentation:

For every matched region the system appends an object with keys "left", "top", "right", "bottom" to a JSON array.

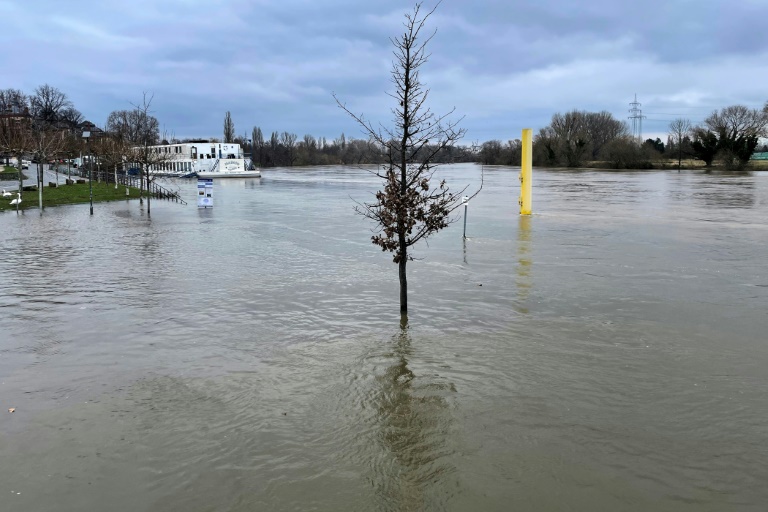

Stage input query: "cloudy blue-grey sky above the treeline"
[{"left": 0, "top": 0, "right": 768, "bottom": 143}]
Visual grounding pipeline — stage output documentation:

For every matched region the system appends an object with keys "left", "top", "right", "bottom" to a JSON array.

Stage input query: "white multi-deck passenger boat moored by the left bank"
[{"left": 132, "top": 142, "right": 261, "bottom": 178}]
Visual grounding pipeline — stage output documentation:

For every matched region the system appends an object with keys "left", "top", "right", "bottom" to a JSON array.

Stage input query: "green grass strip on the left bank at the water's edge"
[{"left": 0, "top": 182, "right": 139, "bottom": 211}]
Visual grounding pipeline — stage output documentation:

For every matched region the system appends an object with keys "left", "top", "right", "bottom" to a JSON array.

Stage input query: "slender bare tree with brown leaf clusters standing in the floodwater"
[{"left": 334, "top": 3, "right": 479, "bottom": 325}]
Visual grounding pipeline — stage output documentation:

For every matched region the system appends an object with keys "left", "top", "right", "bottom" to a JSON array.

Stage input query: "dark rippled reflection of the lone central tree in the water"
[{"left": 372, "top": 318, "right": 457, "bottom": 511}]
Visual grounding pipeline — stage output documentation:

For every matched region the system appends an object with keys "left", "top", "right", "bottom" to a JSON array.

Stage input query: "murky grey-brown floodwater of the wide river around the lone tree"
[{"left": 0, "top": 165, "right": 768, "bottom": 512}]
